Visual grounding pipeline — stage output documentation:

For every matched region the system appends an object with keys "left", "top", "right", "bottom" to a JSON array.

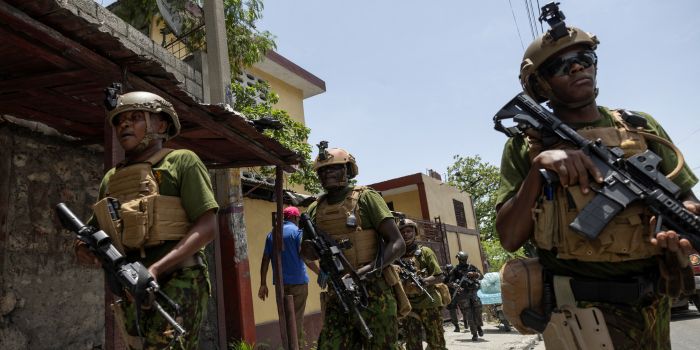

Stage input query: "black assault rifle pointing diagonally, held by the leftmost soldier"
[{"left": 56, "top": 203, "right": 186, "bottom": 339}]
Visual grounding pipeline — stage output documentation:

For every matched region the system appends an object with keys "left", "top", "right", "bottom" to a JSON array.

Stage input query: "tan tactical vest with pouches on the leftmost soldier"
[{"left": 93, "top": 149, "right": 190, "bottom": 257}]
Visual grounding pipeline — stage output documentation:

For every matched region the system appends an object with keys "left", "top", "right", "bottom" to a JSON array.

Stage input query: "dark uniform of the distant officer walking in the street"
[{"left": 447, "top": 263, "right": 484, "bottom": 337}]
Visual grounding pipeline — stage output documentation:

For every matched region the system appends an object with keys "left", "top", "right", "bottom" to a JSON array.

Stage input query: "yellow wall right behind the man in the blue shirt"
[{"left": 243, "top": 198, "right": 321, "bottom": 324}]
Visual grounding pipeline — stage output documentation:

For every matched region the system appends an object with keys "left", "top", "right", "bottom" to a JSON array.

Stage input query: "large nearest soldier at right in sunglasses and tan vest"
[{"left": 496, "top": 4, "right": 700, "bottom": 350}]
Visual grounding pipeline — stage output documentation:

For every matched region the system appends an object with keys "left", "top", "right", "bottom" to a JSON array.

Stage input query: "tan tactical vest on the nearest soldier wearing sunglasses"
[{"left": 528, "top": 111, "right": 660, "bottom": 262}]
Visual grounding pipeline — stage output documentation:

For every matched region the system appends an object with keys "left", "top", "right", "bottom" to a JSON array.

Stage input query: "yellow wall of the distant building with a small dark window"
[{"left": 422, "top": 175, "right": 476, "bottom": 229}]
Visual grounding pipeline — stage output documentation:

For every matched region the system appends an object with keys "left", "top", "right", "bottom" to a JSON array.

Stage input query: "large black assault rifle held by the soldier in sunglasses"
[{"left": 493, "top": 92, "right": 700, "bottom": 250}]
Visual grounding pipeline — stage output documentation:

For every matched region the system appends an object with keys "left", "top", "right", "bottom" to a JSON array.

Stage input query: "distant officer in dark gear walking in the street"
[{"left": 447, "top": 251, "right": 484, "bottom": 341}]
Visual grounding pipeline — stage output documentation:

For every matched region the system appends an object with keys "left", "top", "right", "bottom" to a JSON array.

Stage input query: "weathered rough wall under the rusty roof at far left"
[{"left": 0, "top": 121, "right": 104, "bottom": 350}]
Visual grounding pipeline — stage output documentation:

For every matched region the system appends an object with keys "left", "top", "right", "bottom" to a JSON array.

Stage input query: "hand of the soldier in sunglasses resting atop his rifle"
[{"left": 532, "top": 149, "right": 603, "bottom": 193}]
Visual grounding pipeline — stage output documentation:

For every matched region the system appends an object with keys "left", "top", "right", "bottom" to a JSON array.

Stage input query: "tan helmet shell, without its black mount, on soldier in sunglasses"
[{"left": 519, "top": 27, "right": 599, "bottom": 102}]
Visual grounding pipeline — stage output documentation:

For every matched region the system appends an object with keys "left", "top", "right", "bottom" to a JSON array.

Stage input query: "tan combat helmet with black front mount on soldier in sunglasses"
[{"left": 519, "top": 3, "right": 600, "bottom": 108}]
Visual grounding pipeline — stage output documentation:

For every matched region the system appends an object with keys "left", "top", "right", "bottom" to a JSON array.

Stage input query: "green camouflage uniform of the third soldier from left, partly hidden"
[{"left": 401, "top": 246, "right": 447, "bottom": 350}]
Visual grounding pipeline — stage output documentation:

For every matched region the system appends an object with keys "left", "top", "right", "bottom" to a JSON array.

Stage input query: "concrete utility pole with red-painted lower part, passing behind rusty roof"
[{"left": 204, "top": 0, "right": 255, "bottom": 350}]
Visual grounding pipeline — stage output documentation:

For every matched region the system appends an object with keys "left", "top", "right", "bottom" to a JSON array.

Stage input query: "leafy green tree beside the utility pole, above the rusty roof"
[{"left": 113, "top": 0, "right": 320, "bottom": 193}]
